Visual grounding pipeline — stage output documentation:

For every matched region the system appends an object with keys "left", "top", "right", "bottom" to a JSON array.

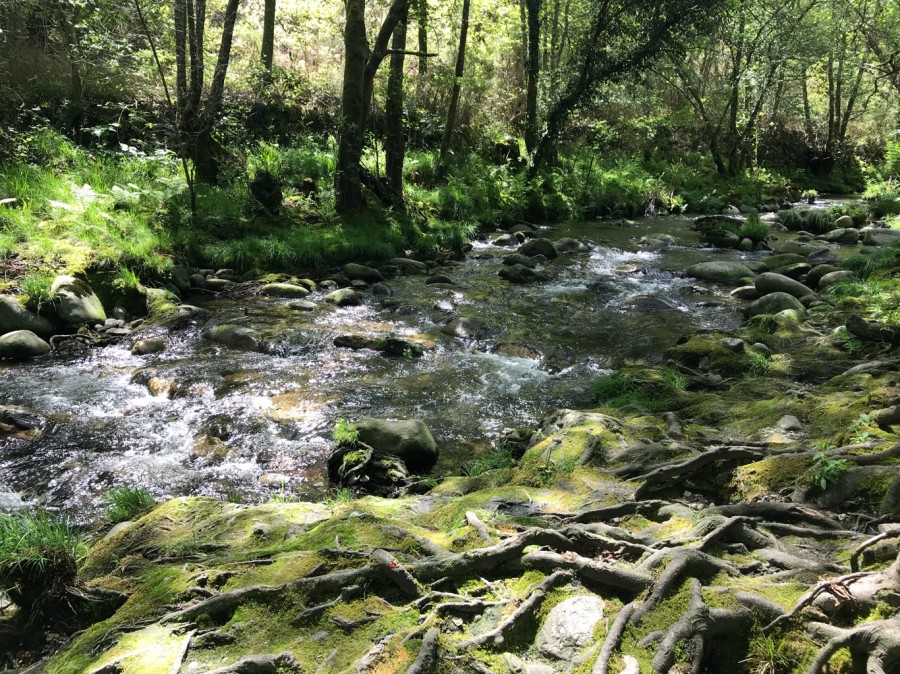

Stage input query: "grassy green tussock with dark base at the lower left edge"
[{"left": 0, "top": 512, "right": 87, "bottom": 618}]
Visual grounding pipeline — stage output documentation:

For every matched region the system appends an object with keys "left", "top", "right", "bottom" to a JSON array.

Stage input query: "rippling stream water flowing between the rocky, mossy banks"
[{"left": 0, "top": 217, "right": 756, "bottom": 520}]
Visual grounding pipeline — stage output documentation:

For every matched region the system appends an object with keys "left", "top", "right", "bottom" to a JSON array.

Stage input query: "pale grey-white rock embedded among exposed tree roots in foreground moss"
[{"left": 535, "top": 595, "right": 604, "bottom": 662}]
